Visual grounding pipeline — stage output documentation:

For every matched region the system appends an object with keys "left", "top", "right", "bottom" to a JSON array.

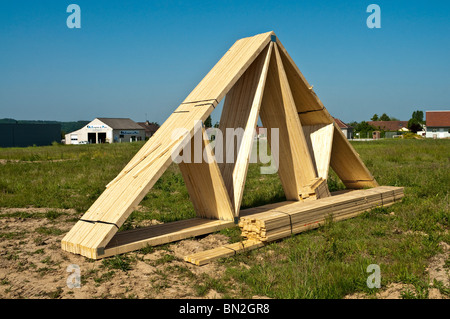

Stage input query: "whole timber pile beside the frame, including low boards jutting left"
[{"left": 184, "top": 186, "right": 404, "bottom": 266}]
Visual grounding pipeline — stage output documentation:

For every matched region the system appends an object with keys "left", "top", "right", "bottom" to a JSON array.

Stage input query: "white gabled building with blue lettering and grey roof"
[{"left": 66, "top": 117, "right": 145, "bottom": 144}]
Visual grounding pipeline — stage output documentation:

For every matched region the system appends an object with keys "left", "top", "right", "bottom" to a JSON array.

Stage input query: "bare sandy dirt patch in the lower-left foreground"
[{"left": 0, "top": 207, "right": 232, "bottom": 299}]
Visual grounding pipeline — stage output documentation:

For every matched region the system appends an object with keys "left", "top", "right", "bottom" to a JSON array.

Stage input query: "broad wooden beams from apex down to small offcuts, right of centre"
[{"left": 260, "top": 45, "right": 317, "bottom": 200}]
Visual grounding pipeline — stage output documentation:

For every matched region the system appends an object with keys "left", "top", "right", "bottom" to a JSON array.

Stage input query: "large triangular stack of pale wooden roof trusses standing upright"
[{"left": 61, "top": 32, "right": 378, "bottom": 259}]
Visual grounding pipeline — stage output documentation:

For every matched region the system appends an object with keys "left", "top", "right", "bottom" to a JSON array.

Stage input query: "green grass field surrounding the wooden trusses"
[{"left": 0, "top": 139, "right": 450, "bottom": 298}]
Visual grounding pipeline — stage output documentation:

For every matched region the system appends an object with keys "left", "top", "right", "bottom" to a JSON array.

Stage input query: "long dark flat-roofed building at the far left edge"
[{"left": 0, "top": 123, "right": 61, "bottom": 147}]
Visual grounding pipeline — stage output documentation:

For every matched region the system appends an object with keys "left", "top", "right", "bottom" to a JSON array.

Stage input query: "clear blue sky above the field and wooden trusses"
[{"left": 0, "top": 0, "right": 450, "bottom": 124}]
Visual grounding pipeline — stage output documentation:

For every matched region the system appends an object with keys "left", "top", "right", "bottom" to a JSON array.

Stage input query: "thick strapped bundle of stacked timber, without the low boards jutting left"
[{"left": 239, "top": 186, "right": 404, "bottom": 242}]
